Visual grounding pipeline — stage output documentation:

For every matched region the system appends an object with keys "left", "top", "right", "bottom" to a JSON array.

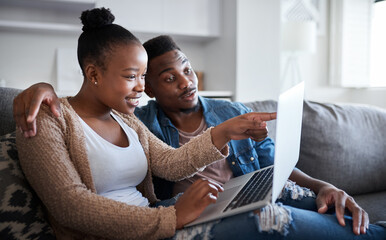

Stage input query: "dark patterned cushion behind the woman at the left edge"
[{"left": 0, "top": 132, "right": 55, "bottom": 239}]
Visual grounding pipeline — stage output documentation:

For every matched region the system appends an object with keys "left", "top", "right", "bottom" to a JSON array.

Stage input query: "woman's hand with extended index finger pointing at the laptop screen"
[{"left": 211, "top": 112, "right": 276, "bottom": 150}]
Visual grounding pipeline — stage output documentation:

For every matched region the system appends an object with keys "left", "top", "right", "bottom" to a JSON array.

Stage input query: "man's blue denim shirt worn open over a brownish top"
[{"left": 135, "top": 96, "right": 274, "bottom": 199}]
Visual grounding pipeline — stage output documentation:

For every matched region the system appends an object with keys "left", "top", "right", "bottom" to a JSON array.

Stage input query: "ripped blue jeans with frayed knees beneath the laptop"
[{"left": 156, "top": 182, "right": 386, "bottom": 240}]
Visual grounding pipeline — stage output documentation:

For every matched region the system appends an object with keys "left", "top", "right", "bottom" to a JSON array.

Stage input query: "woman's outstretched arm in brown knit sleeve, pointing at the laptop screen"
[{"left": 124, "top": 113, "right": 276, "bottom": 181}]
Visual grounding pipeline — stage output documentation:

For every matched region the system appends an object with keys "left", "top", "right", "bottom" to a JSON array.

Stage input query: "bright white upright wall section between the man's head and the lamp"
[{"left": 235, "top": 0, "right": 281, "bottom": 102}]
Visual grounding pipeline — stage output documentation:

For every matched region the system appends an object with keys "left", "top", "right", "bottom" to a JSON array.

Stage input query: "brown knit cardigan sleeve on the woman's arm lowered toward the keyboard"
[{"left": 17, "top": 105, "right": 176, "bottom": 239}]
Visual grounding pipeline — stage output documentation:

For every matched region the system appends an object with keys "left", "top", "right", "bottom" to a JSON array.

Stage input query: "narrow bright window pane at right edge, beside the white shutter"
[{"left": 370, "top": 1, "right": 386, "bottom": 87}]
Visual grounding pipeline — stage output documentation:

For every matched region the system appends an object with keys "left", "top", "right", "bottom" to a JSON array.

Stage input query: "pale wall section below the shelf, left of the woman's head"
[{"left": 0, "top": 30, "right": 78, "bottom": 88}]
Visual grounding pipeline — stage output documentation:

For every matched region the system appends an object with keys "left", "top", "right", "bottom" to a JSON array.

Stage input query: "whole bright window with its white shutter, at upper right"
[{"left": 330, "top": 0, "right": 386, "bottom": 88}]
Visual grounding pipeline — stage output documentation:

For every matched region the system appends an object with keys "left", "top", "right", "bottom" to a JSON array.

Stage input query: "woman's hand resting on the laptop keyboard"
[{"left": 174, "top": 179, "right": 224, "bottom": 229}]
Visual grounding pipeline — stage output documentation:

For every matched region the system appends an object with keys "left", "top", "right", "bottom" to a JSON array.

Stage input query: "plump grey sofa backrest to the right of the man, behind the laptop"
[{"left": 246, "top": 101, "right": 386, "bottom": 195}]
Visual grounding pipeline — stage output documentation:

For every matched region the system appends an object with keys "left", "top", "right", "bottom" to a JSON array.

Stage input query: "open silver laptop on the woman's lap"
[{"left": 185, "top": 82, "right": 304, "bottom": 227}]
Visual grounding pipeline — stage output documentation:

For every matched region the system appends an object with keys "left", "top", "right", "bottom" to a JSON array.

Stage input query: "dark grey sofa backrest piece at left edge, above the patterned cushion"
[{"left": 0, "top": 87, "right": 21, "bottom": 136}]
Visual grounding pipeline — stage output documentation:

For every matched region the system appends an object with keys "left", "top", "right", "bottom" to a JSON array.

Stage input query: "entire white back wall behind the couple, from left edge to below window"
[{"left": 0, "top": 0, "right": 386, "bottom": 108}]
